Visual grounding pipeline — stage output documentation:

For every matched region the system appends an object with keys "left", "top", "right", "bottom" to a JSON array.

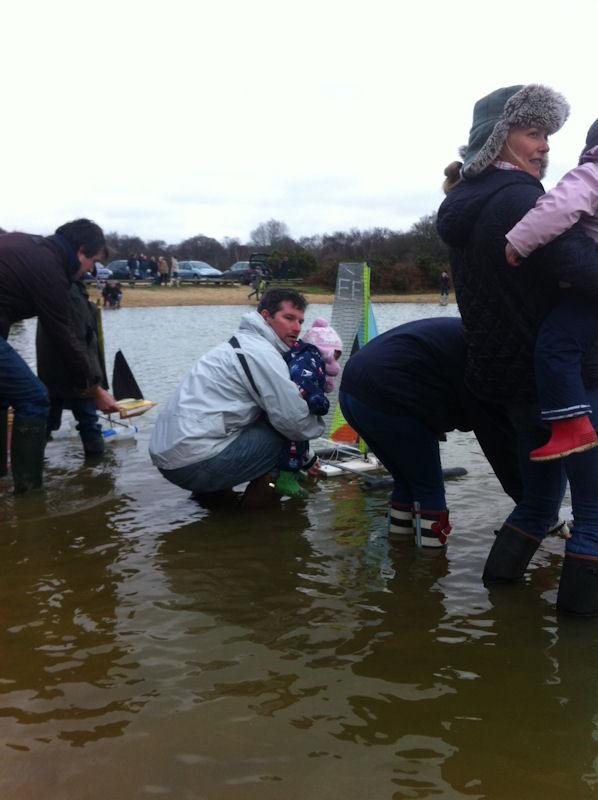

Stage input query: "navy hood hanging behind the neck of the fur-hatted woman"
[{"left": 436, "top": 167, "right": 542, "bottom": 247}]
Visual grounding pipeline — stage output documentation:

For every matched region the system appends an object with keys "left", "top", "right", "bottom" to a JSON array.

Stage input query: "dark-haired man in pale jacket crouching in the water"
[{"left": 150, "top": 289, "right": 324, "bottom": 506}]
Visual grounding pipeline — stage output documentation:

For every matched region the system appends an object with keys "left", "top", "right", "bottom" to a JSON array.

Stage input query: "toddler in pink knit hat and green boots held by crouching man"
[{"left": 274, "top": 317, "right": 343, "bottom": 497}]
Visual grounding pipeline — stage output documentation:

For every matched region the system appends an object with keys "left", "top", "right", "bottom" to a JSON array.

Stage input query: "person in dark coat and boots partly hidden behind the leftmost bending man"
[{"left": 35, "top": 281, "right": 108, "bottom": 457}]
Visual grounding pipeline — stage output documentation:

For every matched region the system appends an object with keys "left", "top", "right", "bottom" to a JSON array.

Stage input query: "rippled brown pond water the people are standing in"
[{"left": 0, "top": 304, "right": 598, "bottom": 800}]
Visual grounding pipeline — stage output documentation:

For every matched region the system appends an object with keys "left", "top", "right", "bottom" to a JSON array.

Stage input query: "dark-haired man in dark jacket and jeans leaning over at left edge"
[{"left": 0, "top": 219, "right": 118, "bottom": 493}]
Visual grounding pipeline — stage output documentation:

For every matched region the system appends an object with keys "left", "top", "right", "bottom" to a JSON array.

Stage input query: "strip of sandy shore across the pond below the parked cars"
[{"left": 89, "top": 284, "right": 438, "bottom": 308}]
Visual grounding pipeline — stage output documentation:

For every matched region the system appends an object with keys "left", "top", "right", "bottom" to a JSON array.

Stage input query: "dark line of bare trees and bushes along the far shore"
[{"left": 0, "top": 214, "right": 448, "bottom": 292}]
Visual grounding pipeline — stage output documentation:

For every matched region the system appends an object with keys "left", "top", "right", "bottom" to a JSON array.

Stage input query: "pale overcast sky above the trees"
[{"left": 0, "top": 0, "right": 598, "bottom": 244}]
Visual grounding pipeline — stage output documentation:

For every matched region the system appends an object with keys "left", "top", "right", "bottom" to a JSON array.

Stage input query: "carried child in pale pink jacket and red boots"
[{"left": 505, "top": 120, "right": 598, "bottom": 461}]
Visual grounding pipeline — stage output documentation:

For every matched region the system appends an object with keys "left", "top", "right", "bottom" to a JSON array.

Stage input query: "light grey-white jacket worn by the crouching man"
[{"left": 150, "top": 311, "right": 324, "bottom": 469}]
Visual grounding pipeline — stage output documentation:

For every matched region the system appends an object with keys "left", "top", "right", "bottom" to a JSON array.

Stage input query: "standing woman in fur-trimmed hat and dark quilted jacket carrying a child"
[{"left": 438, "top": 84, "right": 598, "bottom": 615}]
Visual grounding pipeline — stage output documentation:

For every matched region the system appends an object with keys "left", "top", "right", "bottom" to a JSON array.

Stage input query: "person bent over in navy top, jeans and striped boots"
[{"left": 339, "top": 317, "right": 524, "bottom": 548}]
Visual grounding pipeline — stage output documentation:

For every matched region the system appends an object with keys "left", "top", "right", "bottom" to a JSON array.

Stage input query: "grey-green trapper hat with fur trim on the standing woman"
[{"left": 459, "top": 83, "right": 569, "bottom": 178}]
